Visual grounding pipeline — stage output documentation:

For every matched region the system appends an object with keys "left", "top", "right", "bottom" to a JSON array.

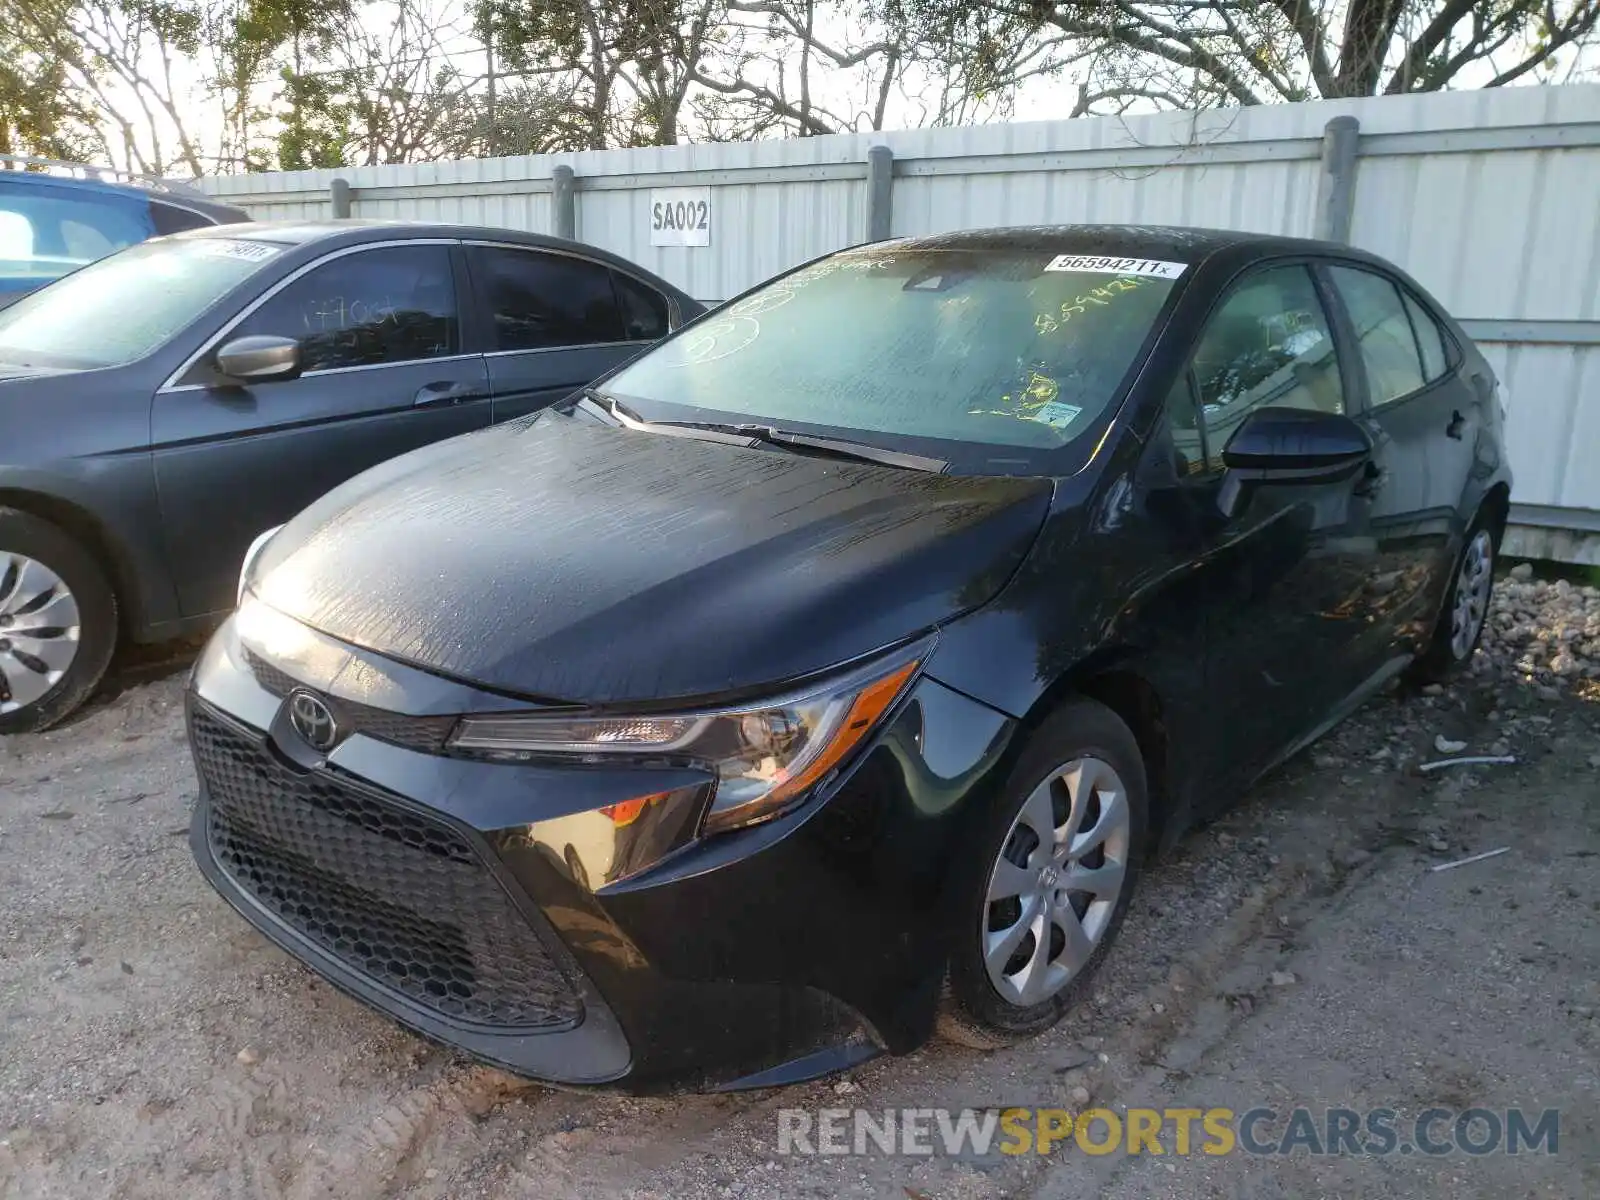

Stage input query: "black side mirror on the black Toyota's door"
[{"left": 1218, "top": 408, "right": 1373, "bottom": 517}]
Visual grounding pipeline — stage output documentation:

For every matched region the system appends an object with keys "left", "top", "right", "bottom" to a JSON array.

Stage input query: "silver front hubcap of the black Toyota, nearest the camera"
[{"left": 982, "top": 758, "right": 1130, "bottom": 1008}]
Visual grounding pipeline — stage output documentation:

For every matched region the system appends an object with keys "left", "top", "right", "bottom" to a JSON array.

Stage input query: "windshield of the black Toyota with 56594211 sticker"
[{"left": 603, "top": 246, "right": 1182, "bottom": 470}]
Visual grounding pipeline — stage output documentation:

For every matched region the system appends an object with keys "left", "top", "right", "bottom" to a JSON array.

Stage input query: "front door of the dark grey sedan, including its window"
[{"left": 152, "top": 240, "right": 490, "bottom": 614}]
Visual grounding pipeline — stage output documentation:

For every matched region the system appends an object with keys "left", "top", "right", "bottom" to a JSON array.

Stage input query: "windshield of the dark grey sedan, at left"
[{"left": 0, "top": 237, "right": 283, "bottom": 370}]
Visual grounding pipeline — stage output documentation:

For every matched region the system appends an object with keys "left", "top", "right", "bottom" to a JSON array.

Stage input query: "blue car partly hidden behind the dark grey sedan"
[{"left": 0, "top": 155, "right": 250, "bottom": 307}]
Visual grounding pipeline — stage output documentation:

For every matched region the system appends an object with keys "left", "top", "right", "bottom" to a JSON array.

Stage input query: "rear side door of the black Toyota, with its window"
[{"left": 1325, "top": 262, "right": 1483, "bottom": 653}]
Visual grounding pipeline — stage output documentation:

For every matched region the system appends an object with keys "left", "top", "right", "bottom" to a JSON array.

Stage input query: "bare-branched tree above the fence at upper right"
[{"left": 882, "top": 0, "right": 1600, "bottom": 112}]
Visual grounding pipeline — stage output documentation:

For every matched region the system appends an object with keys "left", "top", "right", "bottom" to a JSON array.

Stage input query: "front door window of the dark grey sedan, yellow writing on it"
[{"left": 227, "top": 243, "right": 461, "bottom": 371}]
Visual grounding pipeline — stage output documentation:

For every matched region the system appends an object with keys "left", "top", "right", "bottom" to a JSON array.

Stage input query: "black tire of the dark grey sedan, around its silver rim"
[{"left": 0, "top": 507, "right": 117, "bottom": 734}]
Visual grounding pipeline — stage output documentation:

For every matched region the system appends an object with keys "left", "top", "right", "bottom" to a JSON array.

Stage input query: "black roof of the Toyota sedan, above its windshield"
[{"left": 875, "top": 224, "right": 1349, "bottom": 262}]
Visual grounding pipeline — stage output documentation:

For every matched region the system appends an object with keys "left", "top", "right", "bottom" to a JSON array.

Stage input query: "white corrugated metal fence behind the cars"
[{"left": 203, "top": 85, "right": 1600, "bottom": 562}]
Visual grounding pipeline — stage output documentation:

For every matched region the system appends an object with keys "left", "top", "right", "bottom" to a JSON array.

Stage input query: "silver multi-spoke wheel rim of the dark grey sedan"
[{"left": 0, "top": 550, "right": 78, "bottom": 715}]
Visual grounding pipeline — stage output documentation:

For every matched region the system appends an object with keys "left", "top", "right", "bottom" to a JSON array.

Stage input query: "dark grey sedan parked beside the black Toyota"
[{"left": 0, "top": 221, "right": 701, "bottom": 734}]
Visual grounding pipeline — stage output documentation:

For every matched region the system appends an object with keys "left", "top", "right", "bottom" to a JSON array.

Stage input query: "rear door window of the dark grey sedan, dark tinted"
[{"left": 472, "top": 246, "right": 626, "bottom": 350}]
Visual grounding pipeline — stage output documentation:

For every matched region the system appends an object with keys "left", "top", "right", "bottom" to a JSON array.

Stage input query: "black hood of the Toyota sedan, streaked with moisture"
[{"left": 254, "top": 413, "right": 1051, "bottom": 704}]
